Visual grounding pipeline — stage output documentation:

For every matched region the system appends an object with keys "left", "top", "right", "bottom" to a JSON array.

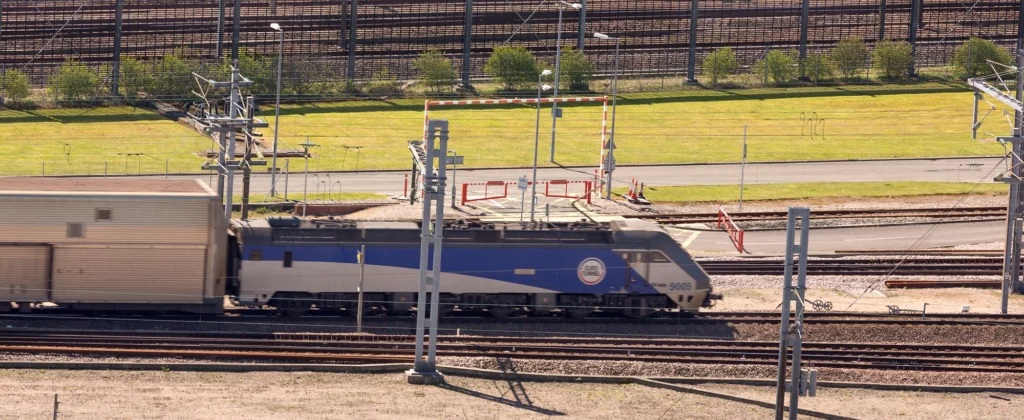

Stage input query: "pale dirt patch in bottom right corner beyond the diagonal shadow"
[{"left": 695, "top": 384, "right": 1024, "bottom": 420}]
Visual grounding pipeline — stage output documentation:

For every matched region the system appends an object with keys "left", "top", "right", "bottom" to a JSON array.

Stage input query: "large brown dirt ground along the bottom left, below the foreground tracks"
[{"left": 0, "top": 370, "right": 771, "bottom": 420}]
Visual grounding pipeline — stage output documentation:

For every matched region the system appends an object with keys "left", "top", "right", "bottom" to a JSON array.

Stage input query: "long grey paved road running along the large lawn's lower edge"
[{"left": 159, "top": 158, "right": 1002, "bottom": 195}]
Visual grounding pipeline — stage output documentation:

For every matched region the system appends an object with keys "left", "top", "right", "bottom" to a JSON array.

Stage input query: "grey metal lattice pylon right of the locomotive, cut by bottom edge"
[{"left": 775, "top": 207, "right": 811, "bottom": 420}]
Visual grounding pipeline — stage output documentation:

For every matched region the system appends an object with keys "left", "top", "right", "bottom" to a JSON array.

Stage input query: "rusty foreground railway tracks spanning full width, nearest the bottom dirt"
[{"left": 0, "top": 331, "right": 1024, "bottom": 373}]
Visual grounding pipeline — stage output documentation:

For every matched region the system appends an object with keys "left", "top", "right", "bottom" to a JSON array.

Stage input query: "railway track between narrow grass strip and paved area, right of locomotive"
[{"left": 624, "top": 207, "right": 1007, "bottom": 224}]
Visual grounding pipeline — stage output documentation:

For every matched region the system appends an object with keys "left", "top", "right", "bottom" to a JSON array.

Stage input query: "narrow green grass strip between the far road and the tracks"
[{"left": 612, "top": 181, "right": 1009, "bottom": 203}]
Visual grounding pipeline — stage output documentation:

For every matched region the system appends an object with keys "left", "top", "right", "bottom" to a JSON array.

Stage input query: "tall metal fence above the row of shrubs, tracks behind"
[{"left": 0, "top": 0, "right": 1024, "bottom": 91}]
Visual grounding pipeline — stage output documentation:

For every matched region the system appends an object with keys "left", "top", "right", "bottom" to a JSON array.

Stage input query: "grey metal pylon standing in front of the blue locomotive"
[{"left": 406, "top": 120, "right": 449, "bottom": 384}]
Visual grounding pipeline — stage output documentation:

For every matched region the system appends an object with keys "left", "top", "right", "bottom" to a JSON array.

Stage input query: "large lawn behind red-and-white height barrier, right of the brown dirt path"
[{"left": 263, "top": 83, "right": 1009, "bottom": 169}]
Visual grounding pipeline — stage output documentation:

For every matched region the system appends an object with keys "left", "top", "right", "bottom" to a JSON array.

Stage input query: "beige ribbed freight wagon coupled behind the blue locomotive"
[{"left": 0, "top": 178, "right": 227, "bottom": 313}]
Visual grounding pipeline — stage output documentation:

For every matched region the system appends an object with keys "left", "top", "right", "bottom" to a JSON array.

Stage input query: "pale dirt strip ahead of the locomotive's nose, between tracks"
[{"left": 711, "top": 288, "right": 1024, "bottom": 313}]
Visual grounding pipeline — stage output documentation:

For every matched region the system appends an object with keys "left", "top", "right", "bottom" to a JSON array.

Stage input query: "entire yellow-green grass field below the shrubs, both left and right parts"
[{"left": 0, "top": 83, "right": 1009, "bottom": 175}]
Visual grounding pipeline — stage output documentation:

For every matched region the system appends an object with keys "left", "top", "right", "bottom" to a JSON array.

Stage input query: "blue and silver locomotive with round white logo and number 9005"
[{"left": 231, "top": 218, "right": 712, "bottom": 318}]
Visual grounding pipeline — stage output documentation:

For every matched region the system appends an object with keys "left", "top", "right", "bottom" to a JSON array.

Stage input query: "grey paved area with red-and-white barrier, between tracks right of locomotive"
[{"left": 670, "top": 221, "right": 1007, "bottom": 254}]
